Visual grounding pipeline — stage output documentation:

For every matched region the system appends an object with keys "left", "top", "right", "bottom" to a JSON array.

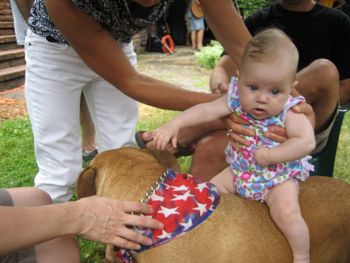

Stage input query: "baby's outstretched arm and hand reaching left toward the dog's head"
[{"left": 153, "top": 95, "right": 231, "bottom": 150}]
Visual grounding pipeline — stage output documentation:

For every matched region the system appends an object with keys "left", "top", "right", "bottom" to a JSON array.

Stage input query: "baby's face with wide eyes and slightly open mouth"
[{"left": 238, "top": 57, "right": 294, "bottom": 120}]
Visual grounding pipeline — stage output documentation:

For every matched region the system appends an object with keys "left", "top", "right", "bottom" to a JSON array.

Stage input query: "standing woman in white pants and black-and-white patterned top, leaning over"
[{"left": 25, "top": 0, "right": 250, "bottom": 202}]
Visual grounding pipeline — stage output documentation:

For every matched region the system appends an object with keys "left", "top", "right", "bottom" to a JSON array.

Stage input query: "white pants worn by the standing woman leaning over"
[{"left": 25, "top": 30, "right": 138, "bottom": 202}]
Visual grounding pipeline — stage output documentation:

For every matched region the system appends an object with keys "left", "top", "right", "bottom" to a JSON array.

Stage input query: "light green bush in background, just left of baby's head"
[{"left": 195, "top": 40, "right": 224, "bottom": 69}]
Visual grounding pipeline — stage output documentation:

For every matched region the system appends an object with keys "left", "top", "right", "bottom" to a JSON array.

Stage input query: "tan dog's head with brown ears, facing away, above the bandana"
[{"left": 77, "top": 148, "right": 179, "bottom": 201}]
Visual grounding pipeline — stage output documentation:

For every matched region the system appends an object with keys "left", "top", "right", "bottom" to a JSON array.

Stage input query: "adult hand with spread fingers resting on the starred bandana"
[{"left": 76, "top": 196, "right": 163, "bottom": 249}]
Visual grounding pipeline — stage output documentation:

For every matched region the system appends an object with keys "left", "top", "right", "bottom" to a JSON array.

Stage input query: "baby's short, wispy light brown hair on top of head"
[{"left": 242, "top": 28, "right": 299, "bottom": 76}]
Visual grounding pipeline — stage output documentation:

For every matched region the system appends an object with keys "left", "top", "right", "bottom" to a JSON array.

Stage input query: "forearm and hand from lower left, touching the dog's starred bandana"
[{"left": 0, "top": 196, "right": 162, "bottom": 255}]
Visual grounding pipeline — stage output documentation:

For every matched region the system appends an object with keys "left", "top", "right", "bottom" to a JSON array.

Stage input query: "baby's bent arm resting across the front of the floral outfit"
[{"left": 254, "top": 110, "right": 316, "bottom": 166}]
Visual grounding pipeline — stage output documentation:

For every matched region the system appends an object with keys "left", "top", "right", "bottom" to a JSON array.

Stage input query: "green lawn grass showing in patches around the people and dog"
[{"left": 0, "top": 105, "right": 350, "bottom": 263}]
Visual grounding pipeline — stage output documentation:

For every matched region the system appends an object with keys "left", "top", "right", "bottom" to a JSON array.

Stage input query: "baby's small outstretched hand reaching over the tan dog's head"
[{"left": 153, "top": 122, "right": 180, "bottom": 150}]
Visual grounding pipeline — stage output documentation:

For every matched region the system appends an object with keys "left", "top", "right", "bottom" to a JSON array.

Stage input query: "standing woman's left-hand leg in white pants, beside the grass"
[{"left": 25, "top": 31, "right": 91, "bottom": 202}]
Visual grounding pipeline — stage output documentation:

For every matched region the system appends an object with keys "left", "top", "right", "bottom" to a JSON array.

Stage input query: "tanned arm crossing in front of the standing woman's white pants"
[{"left": 46, "top": 0, "right": 218, "bottom": 110}]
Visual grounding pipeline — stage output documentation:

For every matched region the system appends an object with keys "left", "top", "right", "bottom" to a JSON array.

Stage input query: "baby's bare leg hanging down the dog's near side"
[{"left": 265, "top": 181, "right": 310, "bottom": 263}]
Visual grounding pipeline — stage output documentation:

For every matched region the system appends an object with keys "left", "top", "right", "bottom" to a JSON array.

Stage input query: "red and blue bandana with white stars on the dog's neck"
[{"left": 117, "top": 170, "right": 220, "bottom": 262}]
